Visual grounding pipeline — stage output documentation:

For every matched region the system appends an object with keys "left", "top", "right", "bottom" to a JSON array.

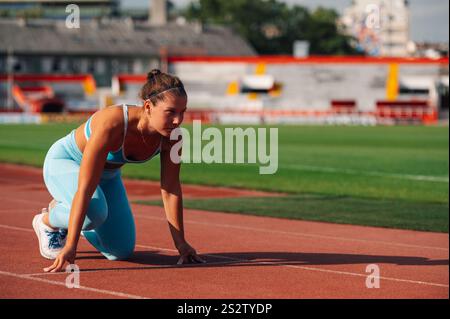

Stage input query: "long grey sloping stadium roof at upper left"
[{"left": 0, "top": 19, "right": 256, "bottom": 56}]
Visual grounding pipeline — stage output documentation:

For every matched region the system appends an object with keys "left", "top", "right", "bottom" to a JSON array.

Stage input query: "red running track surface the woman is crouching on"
[{"left": 0, "top": 165, "right": 449, "bottom": 298}]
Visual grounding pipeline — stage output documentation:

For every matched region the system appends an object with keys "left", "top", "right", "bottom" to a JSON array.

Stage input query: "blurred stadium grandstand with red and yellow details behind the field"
[{"left": 0, "top": 0, "right": 449, "bottom": 125}]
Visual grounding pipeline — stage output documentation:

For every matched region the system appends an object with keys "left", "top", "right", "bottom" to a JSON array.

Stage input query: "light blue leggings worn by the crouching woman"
[{"left": 44, "top": 131, "right": 136, "bottom": 260}]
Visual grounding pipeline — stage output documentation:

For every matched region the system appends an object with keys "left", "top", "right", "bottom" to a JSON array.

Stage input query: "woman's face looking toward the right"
[{"left": 144, "top": 94, "right": 187, "bottom": 137}]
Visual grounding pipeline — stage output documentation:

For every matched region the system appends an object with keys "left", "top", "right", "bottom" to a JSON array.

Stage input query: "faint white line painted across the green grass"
[{"left": 280, "top": 164, "right": 449, "bottom": 183}]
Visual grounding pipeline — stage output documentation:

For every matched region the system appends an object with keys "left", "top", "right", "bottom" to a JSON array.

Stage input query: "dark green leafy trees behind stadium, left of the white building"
[{"left": 183, "top": 0, "right": 358, "bottom": 54}]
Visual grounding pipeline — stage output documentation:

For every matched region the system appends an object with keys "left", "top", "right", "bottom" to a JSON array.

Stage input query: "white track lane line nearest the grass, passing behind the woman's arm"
[{"left": 134, "top": 214, "right": 448, "bottom": 251}]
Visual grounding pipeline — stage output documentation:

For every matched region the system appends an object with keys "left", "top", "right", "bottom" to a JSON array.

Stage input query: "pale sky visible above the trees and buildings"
[{"left": 121, "top": 0, "right": 449, "bottom": 43}]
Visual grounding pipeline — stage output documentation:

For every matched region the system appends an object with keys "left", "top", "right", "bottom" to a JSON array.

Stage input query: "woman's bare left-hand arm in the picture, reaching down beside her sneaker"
[{"left": 44, "top": 122, "right": 118, "bottom": 272}]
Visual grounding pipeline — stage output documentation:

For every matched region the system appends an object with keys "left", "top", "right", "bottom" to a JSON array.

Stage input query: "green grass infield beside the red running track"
[{"left": 0, "top": 124, "right": 449, "bottom": 232}]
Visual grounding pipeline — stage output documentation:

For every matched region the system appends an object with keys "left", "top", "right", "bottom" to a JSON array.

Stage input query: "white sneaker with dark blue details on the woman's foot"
[{"left": 33, "top": 213, "right": 66, "bottom": 259}]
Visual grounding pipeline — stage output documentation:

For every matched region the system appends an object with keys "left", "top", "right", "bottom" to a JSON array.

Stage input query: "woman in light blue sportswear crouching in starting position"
[{"left": 33, "top": 70, "right": 204, "bottom": 272}]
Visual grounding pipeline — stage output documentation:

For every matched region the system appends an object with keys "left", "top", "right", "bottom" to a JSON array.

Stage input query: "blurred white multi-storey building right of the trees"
[{"left": 341, "top": 0, "right": 410, "bottom": 56}]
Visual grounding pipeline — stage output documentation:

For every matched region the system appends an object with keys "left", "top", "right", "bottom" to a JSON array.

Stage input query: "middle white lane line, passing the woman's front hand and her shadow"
[{"left": 0, "top": 225, "right": 449, "bottom": 288}]
